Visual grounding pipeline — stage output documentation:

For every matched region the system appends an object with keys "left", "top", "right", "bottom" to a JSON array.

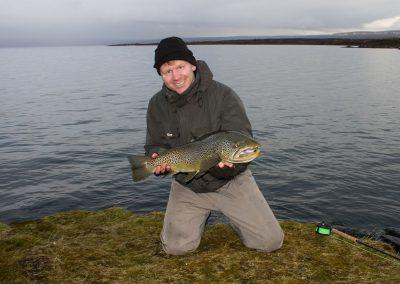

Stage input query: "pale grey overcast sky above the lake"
[{"left": 0, "top": 0, "right": 400, "bottom": 46}]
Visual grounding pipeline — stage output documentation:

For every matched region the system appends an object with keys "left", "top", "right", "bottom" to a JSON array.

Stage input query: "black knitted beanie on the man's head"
[{"left": 153, "top": 37, "right": 196, "bottom": 75}]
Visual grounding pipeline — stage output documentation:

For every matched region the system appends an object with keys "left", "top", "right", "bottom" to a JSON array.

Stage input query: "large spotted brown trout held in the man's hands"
[{"left": 128, "top": 131, "right": 261, "bottom": 183}]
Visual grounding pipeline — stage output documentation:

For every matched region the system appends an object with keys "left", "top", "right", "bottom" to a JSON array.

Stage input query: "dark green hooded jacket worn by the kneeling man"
[{"left": 145, "top": 60, "right": 252, "bottom": 192}]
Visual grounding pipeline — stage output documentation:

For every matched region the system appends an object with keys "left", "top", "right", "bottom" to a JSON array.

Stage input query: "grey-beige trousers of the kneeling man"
[{"left": 161, "top": 170, "right": 283, "bottom": 255}]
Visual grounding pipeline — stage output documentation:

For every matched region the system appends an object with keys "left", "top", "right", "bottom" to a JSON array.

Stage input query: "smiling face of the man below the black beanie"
[{"left": 160, "top": 60, "right": 196, "bottom": 94}]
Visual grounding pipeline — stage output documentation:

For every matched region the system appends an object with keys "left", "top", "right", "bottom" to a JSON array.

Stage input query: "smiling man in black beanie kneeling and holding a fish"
[{"left": 145, "top": 37, "right": 283, "bottom": 255}]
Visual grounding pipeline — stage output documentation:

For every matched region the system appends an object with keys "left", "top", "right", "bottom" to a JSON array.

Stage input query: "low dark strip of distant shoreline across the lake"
[{"left": 108, "top": 38, "right": 400, "bottom": 49}]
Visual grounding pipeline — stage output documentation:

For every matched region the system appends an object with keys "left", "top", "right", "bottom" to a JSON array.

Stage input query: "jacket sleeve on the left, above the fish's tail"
[{"left": 144, "top": 99, "right": 163, "bottom": 156}]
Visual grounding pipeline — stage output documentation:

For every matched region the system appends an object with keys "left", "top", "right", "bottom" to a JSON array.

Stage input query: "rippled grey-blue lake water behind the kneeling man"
[{"left": 0, "top": 46, "right": 400, "bottom": 233}]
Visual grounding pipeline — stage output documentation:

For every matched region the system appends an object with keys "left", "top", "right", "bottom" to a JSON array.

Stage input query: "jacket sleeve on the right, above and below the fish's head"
[{"left": 209, "top": 88, "right": 253, "bottom": 179}]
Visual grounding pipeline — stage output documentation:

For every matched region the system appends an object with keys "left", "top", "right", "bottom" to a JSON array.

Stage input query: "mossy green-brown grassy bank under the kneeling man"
[{"left": 0, "top": 208, "right": 400, "bottom": 283}]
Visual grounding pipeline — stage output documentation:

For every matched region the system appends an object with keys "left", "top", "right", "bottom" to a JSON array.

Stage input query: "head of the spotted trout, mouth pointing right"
[{"left": 221, "top": 132, "right": 261, "bottom": 163}]
